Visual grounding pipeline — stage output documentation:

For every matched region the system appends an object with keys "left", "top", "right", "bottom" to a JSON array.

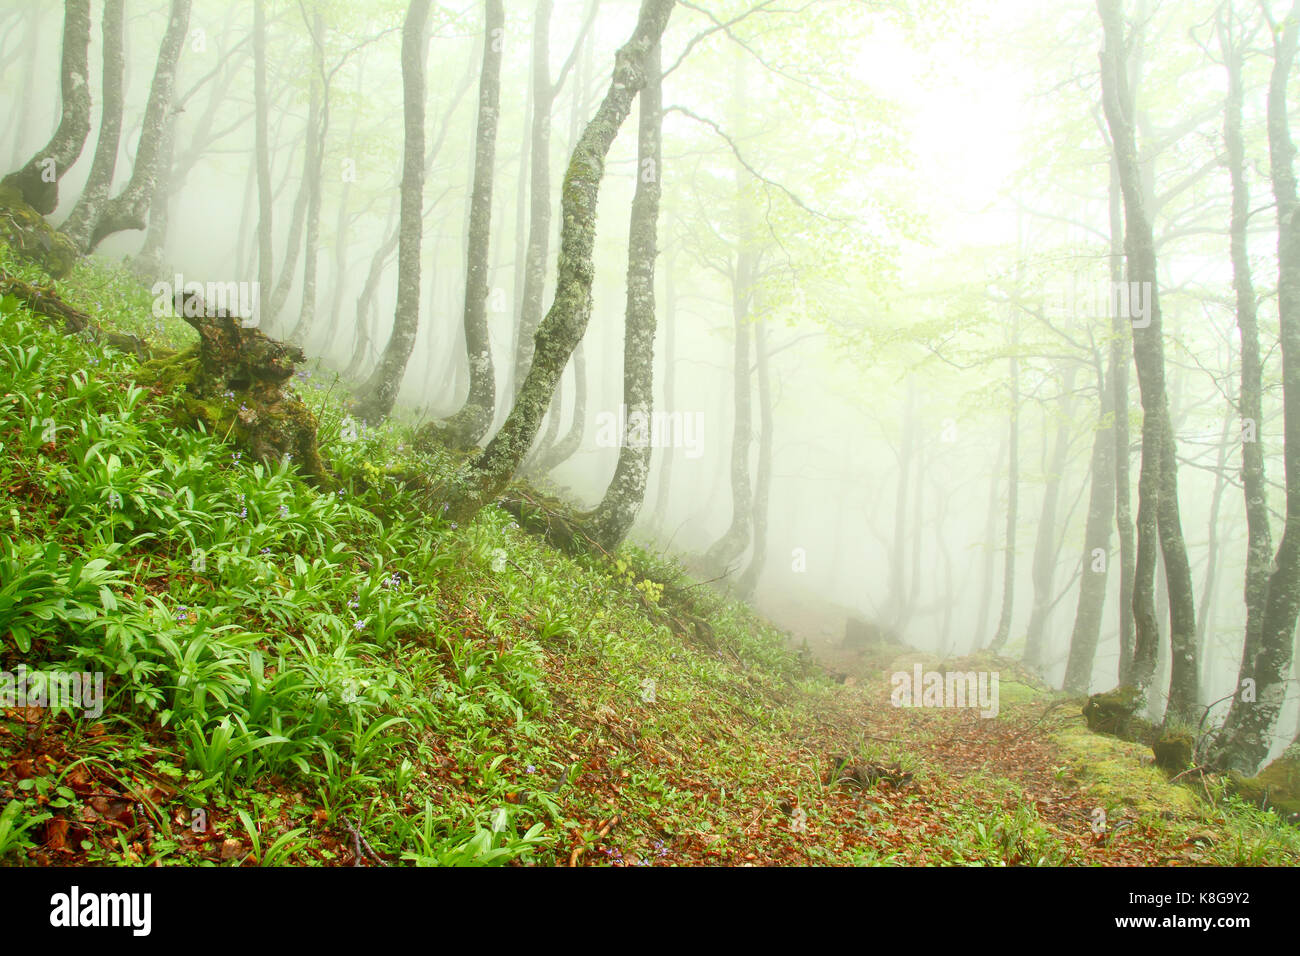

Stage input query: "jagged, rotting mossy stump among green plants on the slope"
[{"left": 146, "top": 315, "right": 332, "bottom": 486}]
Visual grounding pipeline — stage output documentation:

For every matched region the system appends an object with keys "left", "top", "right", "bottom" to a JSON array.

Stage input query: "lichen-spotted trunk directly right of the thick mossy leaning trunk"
[{"left": 589, "top": 43, "right": 672, "bottom": 550}]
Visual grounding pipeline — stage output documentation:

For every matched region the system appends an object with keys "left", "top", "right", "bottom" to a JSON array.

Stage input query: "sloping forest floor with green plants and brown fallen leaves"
[{"left": 0, "top": 250, "right": 1300, "bottom": 866}]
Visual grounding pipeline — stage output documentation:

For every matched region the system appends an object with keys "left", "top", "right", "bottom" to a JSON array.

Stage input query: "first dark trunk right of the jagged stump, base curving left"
[{"left": 352, "top": 0, "right": 430, "bottom": 423}]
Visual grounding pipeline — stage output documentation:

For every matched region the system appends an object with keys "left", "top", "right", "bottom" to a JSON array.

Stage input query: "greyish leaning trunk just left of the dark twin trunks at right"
[{"left": 1063, "top": 355, "right": 1115, "bottom": 693}]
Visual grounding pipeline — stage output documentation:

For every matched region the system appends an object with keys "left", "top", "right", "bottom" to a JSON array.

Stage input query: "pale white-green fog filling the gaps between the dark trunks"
[{"left": 0, "top": 0, "right": 1300, "bottom": 753}]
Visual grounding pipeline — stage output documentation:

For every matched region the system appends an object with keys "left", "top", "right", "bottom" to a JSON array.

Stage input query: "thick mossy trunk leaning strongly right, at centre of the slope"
[{"left": 452, "top": 0, "right": 675, "bottom": 519}]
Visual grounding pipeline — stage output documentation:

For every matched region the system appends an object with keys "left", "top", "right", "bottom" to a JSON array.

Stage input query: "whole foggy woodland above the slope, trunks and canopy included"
[{"left": 0, "top": 0, "right": 1300, "bottom": 771}]
